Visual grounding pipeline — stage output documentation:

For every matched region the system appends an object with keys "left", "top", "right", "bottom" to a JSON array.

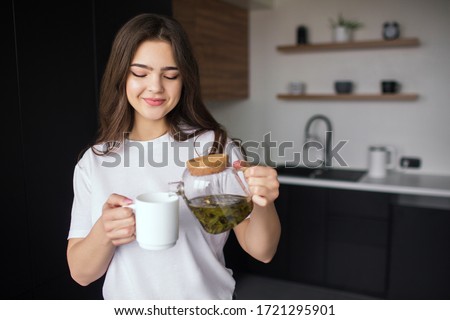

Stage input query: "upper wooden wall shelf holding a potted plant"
[{"left": 277, "top": 38, "right": 420, "bottom": 53}]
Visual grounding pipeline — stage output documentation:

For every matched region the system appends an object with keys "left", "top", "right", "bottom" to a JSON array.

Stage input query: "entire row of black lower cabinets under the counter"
[{"left": 236, "top": 184, "right": 450, "bottom": 299}]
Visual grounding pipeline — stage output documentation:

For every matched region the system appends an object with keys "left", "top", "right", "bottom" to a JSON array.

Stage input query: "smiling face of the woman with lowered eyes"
[{"left": 126, "top": 40, "right": 182, "bottom": 132}]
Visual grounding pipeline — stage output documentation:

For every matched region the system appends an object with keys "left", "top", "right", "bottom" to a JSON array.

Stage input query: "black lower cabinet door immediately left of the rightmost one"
[{"left": 326, "top": 189, "right": 390, "bottom": 297}]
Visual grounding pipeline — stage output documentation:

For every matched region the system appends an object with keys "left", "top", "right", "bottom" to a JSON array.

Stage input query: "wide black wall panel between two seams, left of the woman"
[{"left": 15, "top": 0, "right": 96, "bottom": 292}]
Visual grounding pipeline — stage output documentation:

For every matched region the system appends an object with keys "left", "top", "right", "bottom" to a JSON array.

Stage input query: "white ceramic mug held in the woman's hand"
[{"left": 128, "top": 192, "right": 179, "bottom": 250}]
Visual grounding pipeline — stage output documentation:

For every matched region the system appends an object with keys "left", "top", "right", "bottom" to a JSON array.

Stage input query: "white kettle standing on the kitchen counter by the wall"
[{"left": 368, "top": 145, "right": 396, "bottom": 178}]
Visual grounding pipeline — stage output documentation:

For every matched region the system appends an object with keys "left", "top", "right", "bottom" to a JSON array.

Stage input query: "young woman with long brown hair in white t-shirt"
[{"left": 67, "top": 14, "right": 280, "bottom": 299}]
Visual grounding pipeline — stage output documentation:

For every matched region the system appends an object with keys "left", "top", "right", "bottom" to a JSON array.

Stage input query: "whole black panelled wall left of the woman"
[{"left": 6, "top": 0, "right": 171, "bottom": 299}]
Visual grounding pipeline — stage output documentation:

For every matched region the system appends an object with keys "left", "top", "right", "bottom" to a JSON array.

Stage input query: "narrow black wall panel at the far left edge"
[{"left": 0, "top": 1, "right": 31, "bottom": 299}]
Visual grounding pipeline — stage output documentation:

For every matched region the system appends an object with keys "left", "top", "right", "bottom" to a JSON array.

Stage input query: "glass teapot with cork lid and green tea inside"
[{"left": 169, "top": 154, "right": 253, "bottom": 234}]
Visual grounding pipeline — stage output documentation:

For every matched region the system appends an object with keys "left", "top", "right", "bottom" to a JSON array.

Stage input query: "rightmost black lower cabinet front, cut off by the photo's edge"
[{"left": 388, "top": 200, "right": 450, "bottom": 300}]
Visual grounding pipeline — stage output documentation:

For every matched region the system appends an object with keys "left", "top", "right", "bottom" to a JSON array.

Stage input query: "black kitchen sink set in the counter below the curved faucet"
[{"left": 276, "top": 165, "right": 367, "bottom": 182}]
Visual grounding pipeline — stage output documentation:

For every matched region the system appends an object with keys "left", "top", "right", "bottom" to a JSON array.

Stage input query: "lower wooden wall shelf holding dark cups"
[{"left": 277, "top": 93, "right": 419, "bottom": 101}]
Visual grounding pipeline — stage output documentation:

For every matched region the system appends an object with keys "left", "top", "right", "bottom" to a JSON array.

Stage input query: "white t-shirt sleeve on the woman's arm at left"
[{"left": 67, "top": 154, "right": 93, "bottom": 239}]
